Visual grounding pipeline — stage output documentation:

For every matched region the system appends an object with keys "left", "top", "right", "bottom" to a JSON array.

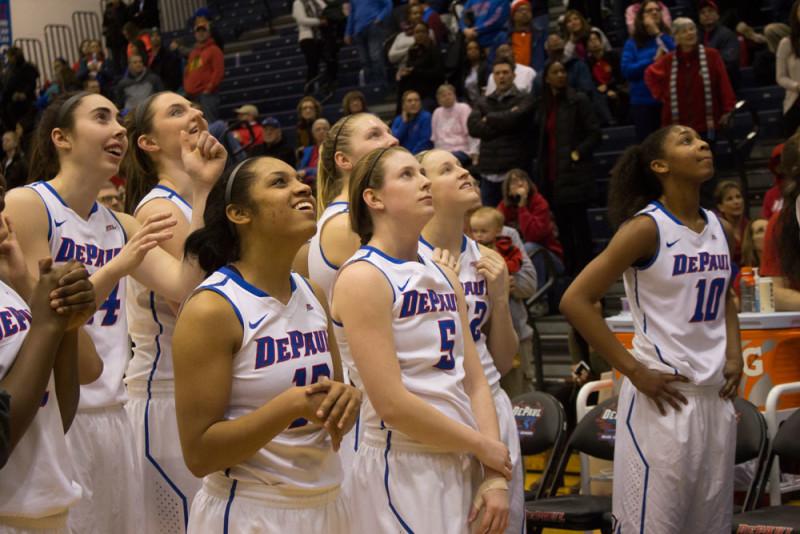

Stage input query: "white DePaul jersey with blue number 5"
[{"left": 334, "top": 246, "right": 477, "bottom": 440}]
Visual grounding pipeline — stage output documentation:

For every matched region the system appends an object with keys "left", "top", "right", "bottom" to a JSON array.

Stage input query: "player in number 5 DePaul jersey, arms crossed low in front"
[{"left": 332, "top": 147, "right": 511, "bottom": 534}]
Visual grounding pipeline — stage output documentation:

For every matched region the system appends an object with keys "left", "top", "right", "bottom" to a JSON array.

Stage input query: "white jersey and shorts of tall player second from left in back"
[{"left": 125, "top": 185, "right": 202, "bottom": 534}]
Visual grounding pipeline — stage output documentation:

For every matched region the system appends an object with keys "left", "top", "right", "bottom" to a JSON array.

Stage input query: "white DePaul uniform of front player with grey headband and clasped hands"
[{"left": 189, "top": 267, "right": 351, "bottom": 534}]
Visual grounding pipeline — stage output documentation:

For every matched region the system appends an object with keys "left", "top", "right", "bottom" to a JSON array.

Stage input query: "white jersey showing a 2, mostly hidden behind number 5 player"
[{"left": 419, "top": 236, "right": 500, "bottom": 392}]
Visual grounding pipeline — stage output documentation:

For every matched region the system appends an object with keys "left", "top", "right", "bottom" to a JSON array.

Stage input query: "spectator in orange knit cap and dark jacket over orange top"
[{"left": 510, "top": 0, "right": 550, "bottom": 71}]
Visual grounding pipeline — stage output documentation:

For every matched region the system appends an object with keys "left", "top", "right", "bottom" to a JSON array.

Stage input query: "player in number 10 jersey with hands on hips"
[{"left": 561, "top": 126, "right": 743, "bottom": 534}]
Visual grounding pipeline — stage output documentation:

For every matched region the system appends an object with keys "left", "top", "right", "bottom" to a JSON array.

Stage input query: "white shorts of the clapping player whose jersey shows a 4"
[{"left": 67, "top": 405, "right": 142, "bottom": 534}]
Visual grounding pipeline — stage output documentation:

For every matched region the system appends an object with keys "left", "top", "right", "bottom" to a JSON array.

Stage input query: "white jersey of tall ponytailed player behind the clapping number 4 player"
[{"left": 126, "top": 185, "right": 192, "bottom": 388}]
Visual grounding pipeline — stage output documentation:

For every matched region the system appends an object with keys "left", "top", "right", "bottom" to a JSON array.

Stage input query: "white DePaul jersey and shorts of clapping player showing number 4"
[{"left": 28, "top": 182, "right": 141, "bottom": 534}]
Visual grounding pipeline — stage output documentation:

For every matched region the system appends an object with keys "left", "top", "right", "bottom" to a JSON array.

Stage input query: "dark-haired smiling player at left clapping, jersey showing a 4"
[{"left": 7, "top": 93, "right": 226, "bottom": 534}]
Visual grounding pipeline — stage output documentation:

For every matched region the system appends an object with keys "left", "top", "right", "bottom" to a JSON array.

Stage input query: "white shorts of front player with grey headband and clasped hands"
[{"left": 188, "top": 473, "right": 354, "bottom": 534}]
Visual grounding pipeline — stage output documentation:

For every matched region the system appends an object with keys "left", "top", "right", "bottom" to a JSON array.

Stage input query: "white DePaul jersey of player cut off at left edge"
[{"left": 0, "top": 281, "right": 81, "bottom": 519}]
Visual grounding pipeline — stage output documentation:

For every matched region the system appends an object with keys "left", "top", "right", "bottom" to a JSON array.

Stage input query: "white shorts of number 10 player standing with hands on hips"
[{"left": 613, "top": 379, "right": 736, "bottom": 534}]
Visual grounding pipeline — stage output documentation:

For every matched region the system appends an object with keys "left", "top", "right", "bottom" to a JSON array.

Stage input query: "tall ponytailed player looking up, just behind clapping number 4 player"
[{"left": 122, "top": 92, "right": 208, "bottom": 534}]
